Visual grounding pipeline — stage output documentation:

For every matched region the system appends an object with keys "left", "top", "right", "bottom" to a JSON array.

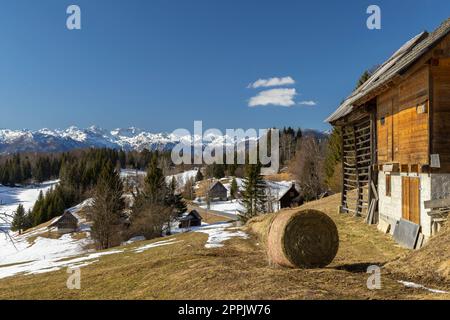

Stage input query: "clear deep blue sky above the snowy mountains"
[{"left": 0, "top": 0, "right": 450, "bottom": 132}]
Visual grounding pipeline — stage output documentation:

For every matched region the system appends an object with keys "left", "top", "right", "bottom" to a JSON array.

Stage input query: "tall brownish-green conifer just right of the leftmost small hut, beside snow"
[{"left": 91, "top": 162, "right": 125, "bottom": 249}]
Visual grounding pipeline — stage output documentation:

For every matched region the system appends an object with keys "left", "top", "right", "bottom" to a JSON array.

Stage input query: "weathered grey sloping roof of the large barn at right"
[{"left": 325, "top": 18, "right": 450, "bottom": 123}]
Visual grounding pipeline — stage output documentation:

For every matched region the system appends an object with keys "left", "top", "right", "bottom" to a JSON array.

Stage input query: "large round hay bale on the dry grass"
[{"left": 267, "top": 209, "right": 339, "bottom": 268}]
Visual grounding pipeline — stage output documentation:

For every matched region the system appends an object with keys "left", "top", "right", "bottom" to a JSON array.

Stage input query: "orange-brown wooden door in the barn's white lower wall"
[{"left": 402, "top": 177, "right": 420, "bottom": 224}]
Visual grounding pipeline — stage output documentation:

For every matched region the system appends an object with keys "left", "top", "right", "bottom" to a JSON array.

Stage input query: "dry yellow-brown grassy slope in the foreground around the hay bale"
[{"left": 0, "top": 192, "right": 449, "bottom": 299}]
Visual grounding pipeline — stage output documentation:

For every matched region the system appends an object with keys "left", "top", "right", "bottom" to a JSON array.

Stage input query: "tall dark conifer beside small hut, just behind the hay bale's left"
[{"left": 239, "top": 164, "right": 267, "bottom": 222}]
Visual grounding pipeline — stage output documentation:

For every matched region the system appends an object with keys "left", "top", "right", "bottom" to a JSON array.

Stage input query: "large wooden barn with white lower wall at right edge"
[{"left": 327, "top": 19, "right": 450, "bottom": 242}]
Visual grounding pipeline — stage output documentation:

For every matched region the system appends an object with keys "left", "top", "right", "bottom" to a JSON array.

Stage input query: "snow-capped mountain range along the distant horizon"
[{"left": 0, "top": 126, "right": 326, "bottom": 154}]
